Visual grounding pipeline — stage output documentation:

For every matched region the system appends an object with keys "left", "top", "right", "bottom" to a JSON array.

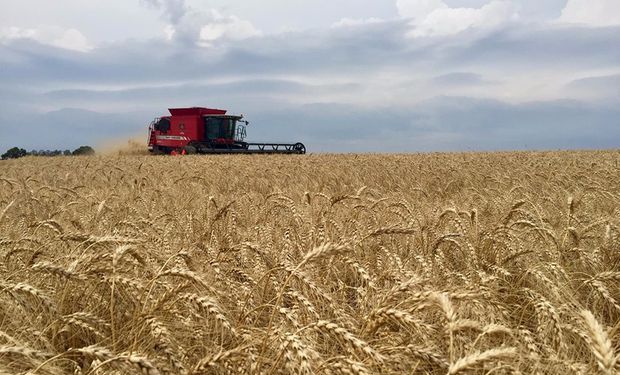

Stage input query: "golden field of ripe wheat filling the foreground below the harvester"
[{"left": 0, "top": 151, "right": 620, "bottom": 374}]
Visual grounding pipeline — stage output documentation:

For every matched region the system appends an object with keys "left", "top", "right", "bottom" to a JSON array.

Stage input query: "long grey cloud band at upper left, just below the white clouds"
[{"left": 0, "top": 22, "right": 422, "bottom": 84}]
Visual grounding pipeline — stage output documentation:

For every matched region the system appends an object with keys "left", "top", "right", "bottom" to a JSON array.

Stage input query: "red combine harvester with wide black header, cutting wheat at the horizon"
[{"left": 149, "top": 107, "right": 306, "bottom": 154}]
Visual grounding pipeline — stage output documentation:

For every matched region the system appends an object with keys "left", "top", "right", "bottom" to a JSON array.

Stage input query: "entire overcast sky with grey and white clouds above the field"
[{"left": 0, "top": 0, "right": 620, "bottom": 152}]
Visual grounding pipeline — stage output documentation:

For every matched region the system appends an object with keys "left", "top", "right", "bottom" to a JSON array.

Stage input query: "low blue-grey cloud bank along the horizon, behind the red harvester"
[{"left": 0, "top": 97, "right": 620, "bottom": 152}]
